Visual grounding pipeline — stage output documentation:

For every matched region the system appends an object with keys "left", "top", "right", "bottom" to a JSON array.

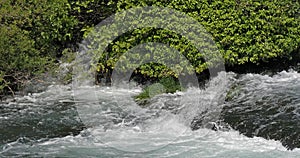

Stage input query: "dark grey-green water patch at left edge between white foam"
[{"left": 0, "top": 102, "right": 85, "bottom": 144}]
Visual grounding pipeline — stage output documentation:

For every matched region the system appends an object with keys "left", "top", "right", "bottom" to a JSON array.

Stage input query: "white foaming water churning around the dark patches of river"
[{"left": 0, "top": 72, "right": 300, "bottom": 158}]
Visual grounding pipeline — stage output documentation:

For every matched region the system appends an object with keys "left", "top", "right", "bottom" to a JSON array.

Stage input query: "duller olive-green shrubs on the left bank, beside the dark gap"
[{"left": 0, "top": 0, "right": 77, "bottom": 93}]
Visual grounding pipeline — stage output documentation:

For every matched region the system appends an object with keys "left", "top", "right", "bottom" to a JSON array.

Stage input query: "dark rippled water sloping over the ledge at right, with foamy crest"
[{"left": 221, "top": 71, "right": 300, "bottom": 149}]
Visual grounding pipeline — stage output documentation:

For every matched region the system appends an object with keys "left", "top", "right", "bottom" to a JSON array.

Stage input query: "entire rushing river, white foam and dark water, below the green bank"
[{"left": 0, "top": 71, "right": 300, "bottom": 158}]
